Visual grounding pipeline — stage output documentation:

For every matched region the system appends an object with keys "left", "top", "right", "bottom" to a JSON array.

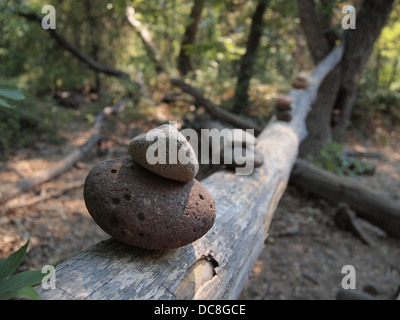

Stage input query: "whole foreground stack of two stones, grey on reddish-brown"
[{"left": 84, "top": 125, "right": 216, "bottom": 250}]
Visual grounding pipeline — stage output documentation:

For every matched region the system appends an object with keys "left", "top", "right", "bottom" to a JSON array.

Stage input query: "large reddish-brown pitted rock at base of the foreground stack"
[{"left": 84, "top": 158, "right": 216, "bottom": 250}]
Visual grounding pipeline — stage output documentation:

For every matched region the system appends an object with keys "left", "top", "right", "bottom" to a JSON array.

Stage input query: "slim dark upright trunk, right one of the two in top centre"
[{"left": 233, "top": 0, "right": 269, "bottom": 113}]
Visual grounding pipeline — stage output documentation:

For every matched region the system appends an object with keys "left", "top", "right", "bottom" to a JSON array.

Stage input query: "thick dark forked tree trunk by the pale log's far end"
[{"left": 298, "top": 0, "right": 394, "bottom": 157}]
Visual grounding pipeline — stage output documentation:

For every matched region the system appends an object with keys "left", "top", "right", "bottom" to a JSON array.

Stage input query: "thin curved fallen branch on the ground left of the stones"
[{"left": 0, "top": 99, "right": 126, "bottom": 204}]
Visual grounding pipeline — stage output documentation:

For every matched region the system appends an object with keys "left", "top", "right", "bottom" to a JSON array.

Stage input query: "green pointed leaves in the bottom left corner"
[{"left": 0, "top": 240, "right": 56, "bottom": 300}]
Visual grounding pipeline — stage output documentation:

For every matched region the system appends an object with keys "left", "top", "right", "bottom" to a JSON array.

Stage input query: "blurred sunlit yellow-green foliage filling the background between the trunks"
[{"left": 0, "top": 0, "right": 394, "bottom": 151}]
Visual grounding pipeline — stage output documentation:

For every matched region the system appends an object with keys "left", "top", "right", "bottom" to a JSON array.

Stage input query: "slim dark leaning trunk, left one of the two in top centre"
[{"left": 178, "top": 0, "right": 205, "bottom": 75}]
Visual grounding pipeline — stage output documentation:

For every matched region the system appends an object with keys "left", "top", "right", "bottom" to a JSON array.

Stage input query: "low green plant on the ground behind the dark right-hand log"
[{"left": 308, "top": 142, "right": 373, "bottom": 176}]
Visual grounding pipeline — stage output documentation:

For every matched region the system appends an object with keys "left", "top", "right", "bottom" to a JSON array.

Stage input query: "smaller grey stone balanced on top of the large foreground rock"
[{"left": 128, "top": 124, "right": 199, "bottom": 182}]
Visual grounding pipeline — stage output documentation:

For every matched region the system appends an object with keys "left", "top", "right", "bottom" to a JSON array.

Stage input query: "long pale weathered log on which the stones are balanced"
[{"left": 37, "top": 43, "right": 341, "bottom": 300}]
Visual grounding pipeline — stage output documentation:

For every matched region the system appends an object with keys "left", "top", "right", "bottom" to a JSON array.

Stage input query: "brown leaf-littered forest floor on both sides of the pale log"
[{"left": 0, "top": 103, "right": 400, "bottom": 299}]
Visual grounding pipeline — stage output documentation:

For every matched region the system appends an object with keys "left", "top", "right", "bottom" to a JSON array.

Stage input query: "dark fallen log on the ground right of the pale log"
[{"left": 290, "top": 159, "right": 400, "bottom": 237}]
